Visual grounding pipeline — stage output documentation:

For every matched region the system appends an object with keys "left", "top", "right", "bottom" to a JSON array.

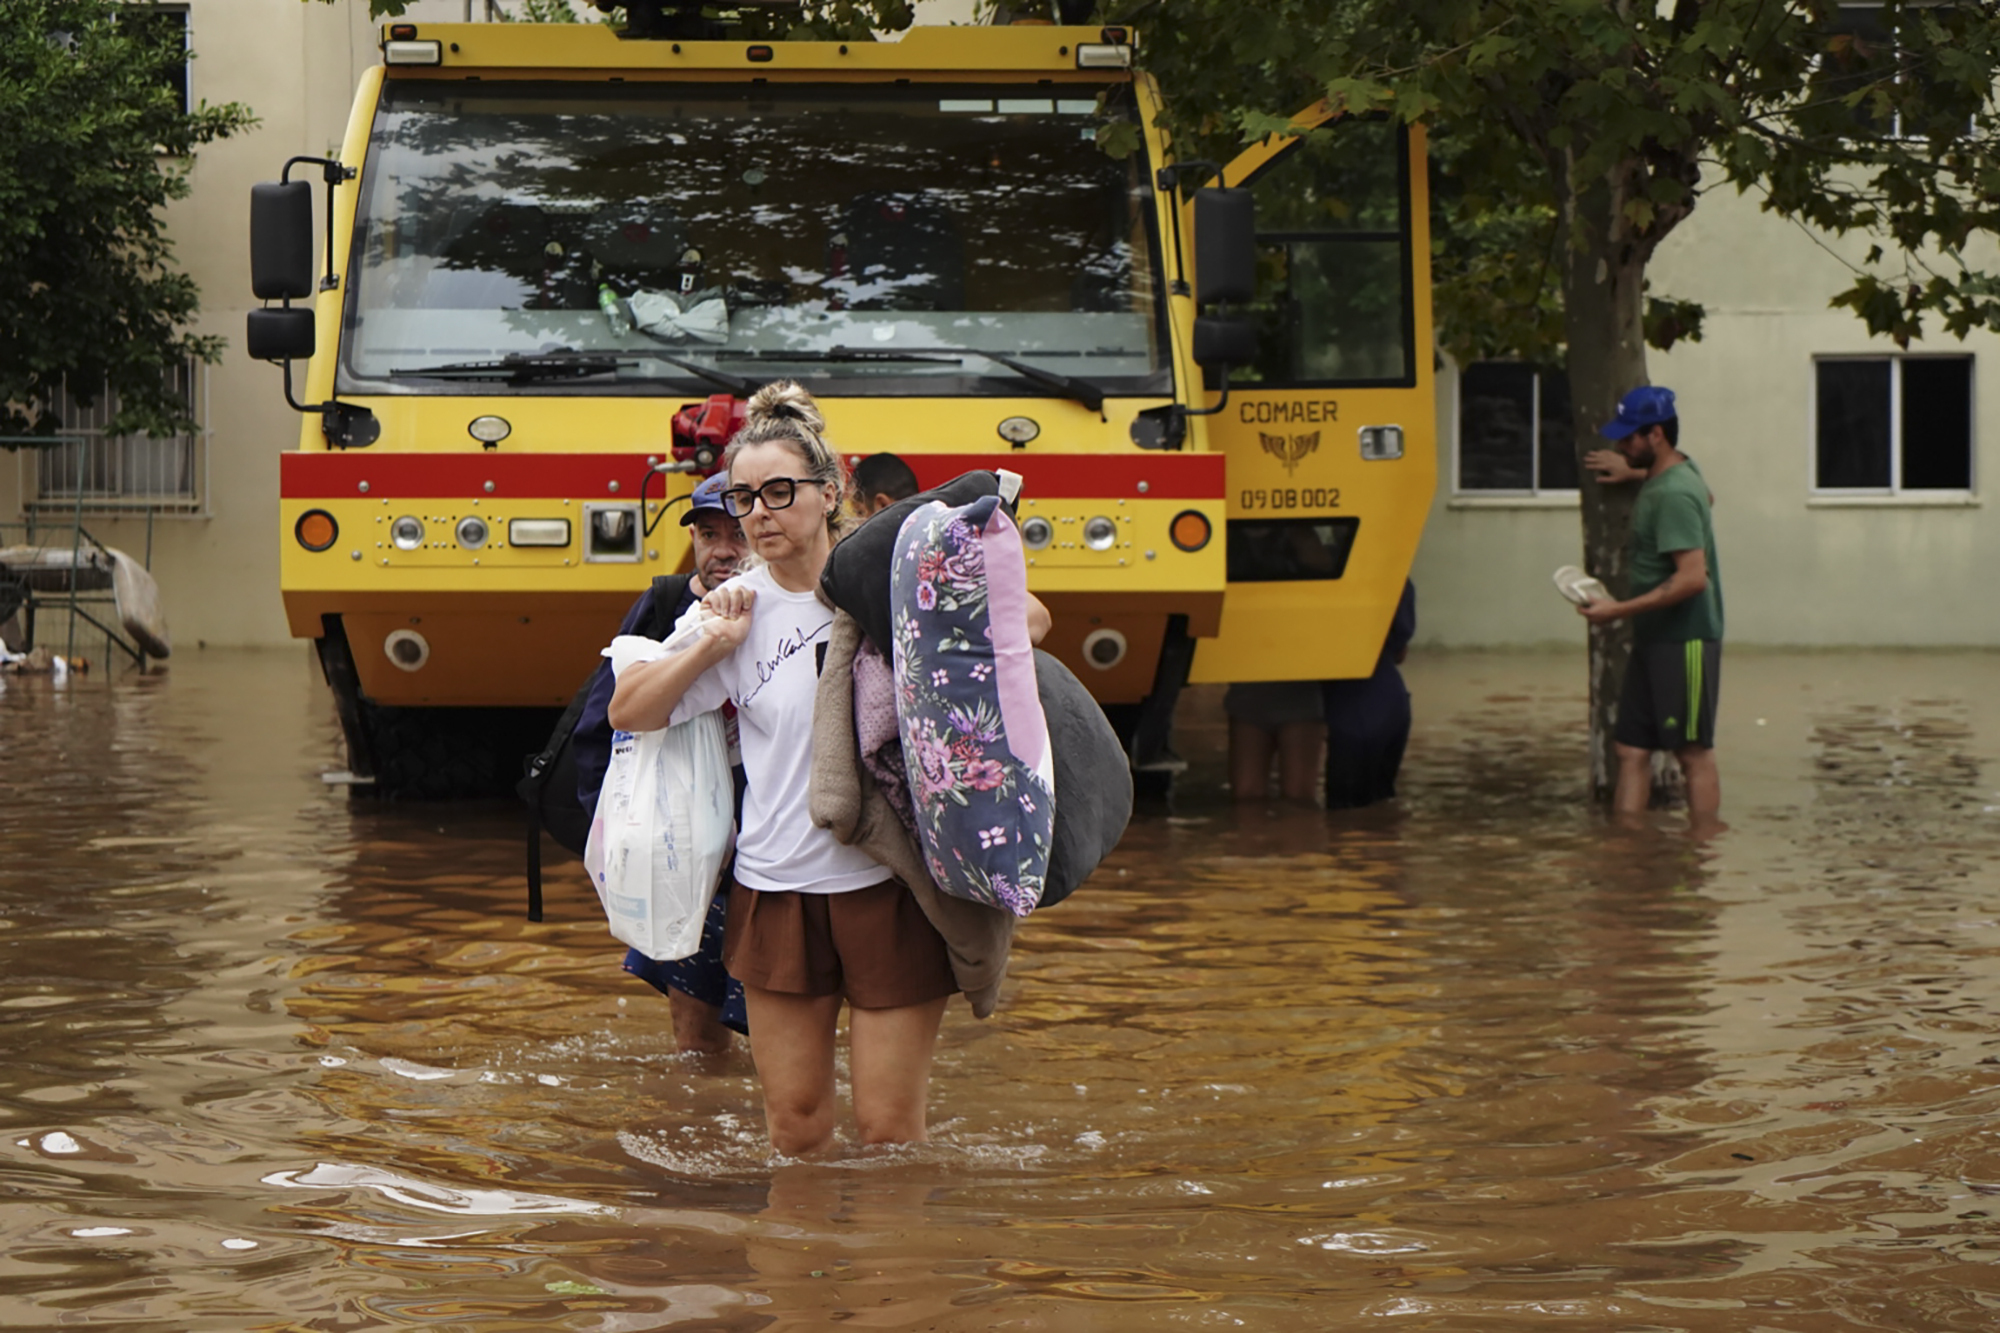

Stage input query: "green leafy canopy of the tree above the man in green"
[{"left": 1110, "top": 0, "right": 2000, "bottom": 360}]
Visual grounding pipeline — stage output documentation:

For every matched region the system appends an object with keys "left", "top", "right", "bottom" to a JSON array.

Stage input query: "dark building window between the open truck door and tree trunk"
[{"left": 1458, "top": 360, "right": 1576, "bottom": 494}]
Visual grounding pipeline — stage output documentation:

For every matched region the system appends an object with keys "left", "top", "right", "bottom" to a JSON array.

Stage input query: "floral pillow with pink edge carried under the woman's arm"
[{"left": 890, "top": 496, "right": 1056, "bottom": 917}]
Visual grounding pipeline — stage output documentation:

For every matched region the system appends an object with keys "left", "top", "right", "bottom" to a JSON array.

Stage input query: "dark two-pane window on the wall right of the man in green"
[{"left": 1812, "top": 356, "right": 1972, "bottom": 494}]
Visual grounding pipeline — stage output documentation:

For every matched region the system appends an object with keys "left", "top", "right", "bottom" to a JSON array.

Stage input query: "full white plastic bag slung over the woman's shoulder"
[{"left": 584, "top": 634, "right": 736, "bottom": 963}]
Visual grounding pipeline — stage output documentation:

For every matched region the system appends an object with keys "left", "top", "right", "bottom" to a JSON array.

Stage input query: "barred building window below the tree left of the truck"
[{"left": 22, "top": 360, "right": 208, "bottom": 514}]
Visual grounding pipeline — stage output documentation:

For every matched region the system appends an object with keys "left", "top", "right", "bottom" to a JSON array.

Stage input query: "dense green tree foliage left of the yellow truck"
[{"left": 0, "top": 0, "right": 252, "bottom": 434}]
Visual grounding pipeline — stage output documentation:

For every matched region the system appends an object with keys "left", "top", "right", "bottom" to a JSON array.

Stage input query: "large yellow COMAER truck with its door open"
[{"left": 250, "top": 22, "right": 1436, "bottom": 793}]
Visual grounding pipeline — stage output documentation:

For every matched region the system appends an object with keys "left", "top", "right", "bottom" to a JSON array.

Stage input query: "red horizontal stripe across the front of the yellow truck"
[{"left": 278, "top": 450, "right": 1224, "bottom": 500}]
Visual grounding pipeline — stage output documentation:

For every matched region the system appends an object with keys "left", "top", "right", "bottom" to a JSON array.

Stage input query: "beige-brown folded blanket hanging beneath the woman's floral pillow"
[{"left": 810, "top": 610, "right": 1014, "bottom": 1019}]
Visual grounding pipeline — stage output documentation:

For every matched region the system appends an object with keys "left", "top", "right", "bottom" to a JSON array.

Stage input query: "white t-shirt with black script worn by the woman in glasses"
[{"left": 674, "top": 566, "right": 892, "bottom": 893}]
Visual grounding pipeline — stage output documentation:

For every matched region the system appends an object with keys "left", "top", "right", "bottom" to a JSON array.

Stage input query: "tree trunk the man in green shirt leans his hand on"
[{"left": 1562, "top": 205, "right": 1650, "bottom": 801}]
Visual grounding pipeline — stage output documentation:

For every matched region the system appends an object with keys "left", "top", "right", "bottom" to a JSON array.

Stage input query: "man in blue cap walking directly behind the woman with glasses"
[{"left": 570, "top": 472, "right": 750, "bottom": 1055}]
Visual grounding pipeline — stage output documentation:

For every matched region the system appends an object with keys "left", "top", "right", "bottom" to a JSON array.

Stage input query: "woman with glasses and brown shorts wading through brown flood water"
[{"left": 610, "top": 382, "right": 958, "bottom": 1155}]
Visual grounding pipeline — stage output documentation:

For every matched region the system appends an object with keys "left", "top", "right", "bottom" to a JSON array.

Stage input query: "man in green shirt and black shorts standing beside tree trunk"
[{"left": 1578, "top": 384, "right": 1722, "bottom": 817}]
